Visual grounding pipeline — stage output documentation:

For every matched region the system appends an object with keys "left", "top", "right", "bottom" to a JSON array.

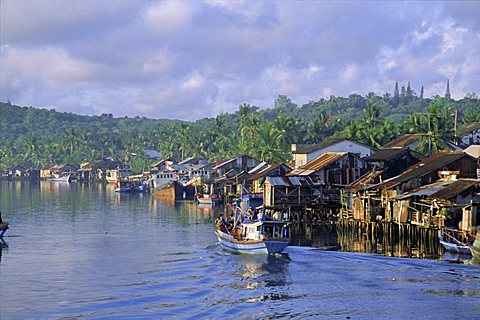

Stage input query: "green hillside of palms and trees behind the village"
[{"left": 0, "top": 83, "right": 480, "bottom": 171}]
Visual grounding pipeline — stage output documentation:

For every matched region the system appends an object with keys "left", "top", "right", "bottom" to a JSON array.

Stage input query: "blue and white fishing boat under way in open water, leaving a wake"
[{"left": 215, "top": 195, "right": 290, "bottom": 254}]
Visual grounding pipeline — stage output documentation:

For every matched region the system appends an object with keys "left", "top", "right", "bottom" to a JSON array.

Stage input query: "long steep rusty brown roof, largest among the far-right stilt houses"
[{"left": 375, "top": 151, "right": 469, "bottom": 189}]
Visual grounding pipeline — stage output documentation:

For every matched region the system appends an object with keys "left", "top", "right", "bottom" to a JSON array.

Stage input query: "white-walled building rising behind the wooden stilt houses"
[{"left": 291, "top": 138, "right": 377, "bottom": 168}]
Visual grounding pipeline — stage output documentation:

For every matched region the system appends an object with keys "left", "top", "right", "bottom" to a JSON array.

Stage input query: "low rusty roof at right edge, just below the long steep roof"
[{"left": 397, "top": 179, "right": 480, "bottom": 200}]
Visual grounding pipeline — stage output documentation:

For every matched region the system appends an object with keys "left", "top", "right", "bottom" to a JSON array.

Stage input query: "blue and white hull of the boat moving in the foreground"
[{"left": 215, "top": 230, "right": 288, "bottom": 254}]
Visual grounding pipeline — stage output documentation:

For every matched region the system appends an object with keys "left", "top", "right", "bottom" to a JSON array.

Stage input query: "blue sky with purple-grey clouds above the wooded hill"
[{"left": 0, "top": 0, "right": 480, "bottom": 121}]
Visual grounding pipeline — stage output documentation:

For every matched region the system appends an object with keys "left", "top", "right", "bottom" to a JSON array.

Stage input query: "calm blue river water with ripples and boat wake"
[{"left": 0, "top": 182, "right": 480, "bottom": 319}]
